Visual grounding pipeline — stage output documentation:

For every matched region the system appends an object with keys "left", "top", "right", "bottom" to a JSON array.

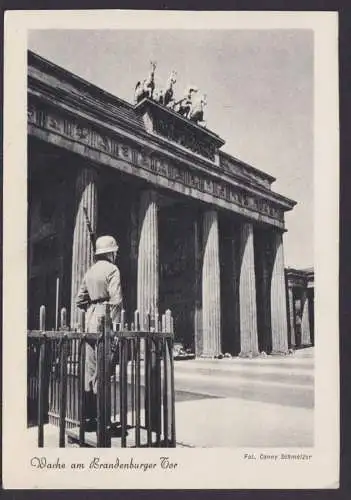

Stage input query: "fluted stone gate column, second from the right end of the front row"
[{"left": 239, "top": 222, "right": 258, "bottom": 357}]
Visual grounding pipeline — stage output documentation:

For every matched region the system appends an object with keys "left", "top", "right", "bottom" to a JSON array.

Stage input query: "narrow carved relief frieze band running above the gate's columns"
[{"left": 28, "top": 105, "right": 284, "bottom": 222}]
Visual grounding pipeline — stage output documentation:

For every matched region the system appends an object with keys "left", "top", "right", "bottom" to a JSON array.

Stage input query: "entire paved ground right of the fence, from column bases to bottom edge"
[{"left": 175, "top": 348, "right": 314, "bottom": 447}]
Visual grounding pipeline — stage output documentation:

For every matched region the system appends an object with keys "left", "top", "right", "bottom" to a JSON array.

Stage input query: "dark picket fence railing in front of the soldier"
[{"left": 28, "top": 305, "right": 176, "bottom": 447}]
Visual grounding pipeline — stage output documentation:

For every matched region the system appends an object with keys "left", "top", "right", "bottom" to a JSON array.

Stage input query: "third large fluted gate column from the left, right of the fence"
[{"left": 201, "top": 210, "right": 221, "bottom": 357}]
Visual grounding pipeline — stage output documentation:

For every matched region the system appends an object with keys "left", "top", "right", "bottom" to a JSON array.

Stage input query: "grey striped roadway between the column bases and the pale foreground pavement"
[{"left": 175, "top": 350, "right": 314, "bottom": 409}]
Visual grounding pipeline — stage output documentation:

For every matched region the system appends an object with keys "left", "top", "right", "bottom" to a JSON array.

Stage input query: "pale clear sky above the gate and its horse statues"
[{"left": 28, "top": 29, "right": 314, "bottom": 268}]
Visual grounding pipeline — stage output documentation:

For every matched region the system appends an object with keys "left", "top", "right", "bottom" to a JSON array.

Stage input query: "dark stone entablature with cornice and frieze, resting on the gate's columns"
[{"left": 28, "top": 50, "right": 295, "bottom": 229}]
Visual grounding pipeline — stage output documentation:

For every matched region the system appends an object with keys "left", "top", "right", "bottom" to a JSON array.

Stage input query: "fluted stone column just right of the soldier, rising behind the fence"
[{"left": 137, "top": 190, "right": 159, "bottom": 325}]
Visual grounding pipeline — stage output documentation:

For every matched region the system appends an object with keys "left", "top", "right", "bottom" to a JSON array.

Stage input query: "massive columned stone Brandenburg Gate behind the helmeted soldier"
[{"left": 28, "top": 52, "right": 295, "bottom": 357}]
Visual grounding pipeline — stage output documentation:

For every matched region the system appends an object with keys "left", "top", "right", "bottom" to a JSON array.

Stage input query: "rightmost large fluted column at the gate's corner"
[{"left": 271, "top": 231, "right": 288, "bottom": 354}]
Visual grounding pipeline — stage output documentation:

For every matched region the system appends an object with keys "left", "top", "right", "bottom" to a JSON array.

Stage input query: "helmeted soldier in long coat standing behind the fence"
[{"left": 76, "top": 236, "right": 122, "bottom": 431}]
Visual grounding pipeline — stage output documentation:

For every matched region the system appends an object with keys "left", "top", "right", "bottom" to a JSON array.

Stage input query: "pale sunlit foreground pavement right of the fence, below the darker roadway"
[{"left": 176, "top": 398, "right": 313, "bottom": 448}]
